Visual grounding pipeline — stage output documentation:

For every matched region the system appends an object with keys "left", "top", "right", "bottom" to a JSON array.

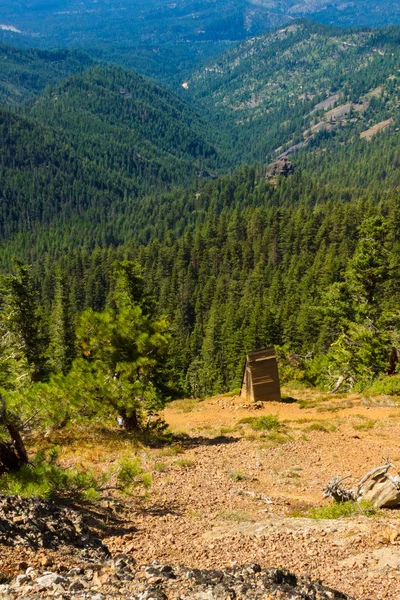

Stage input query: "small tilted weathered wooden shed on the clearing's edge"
[{"left": 240, "top": 348, "right": 282, "bottom": 402}]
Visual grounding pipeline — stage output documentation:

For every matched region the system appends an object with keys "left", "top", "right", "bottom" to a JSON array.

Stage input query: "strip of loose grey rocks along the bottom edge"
[{"left": 0, "top": 555, "right": 350, "bottom": 600}]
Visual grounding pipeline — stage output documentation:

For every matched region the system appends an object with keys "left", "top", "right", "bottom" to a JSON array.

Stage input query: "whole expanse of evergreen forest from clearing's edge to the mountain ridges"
[{"left": 0, "top": 23, "right": 400, "bottom": 454}]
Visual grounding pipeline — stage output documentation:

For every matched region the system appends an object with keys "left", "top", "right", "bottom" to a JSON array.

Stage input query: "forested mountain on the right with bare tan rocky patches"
[{"left": 185, "top": 21, "right": 400, "bottom": 161}]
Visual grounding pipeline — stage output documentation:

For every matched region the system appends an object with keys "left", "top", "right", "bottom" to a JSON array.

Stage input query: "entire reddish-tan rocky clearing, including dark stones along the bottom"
[{"left": 0, "top": 390, "right": 400, "bottom": 600}]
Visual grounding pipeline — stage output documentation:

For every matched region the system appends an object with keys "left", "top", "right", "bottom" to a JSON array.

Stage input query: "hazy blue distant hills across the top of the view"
[{"left": 1, "top": 0, "right": 400, "bottom": 51}]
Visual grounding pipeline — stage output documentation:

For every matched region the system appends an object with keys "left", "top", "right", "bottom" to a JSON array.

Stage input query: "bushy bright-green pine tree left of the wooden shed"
[{"left": 69, "top": 262, "right": 169, "bottom": 431}]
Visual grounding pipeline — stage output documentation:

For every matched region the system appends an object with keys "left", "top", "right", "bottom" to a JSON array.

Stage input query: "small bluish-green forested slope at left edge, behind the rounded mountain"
[{"left": 0, "top": 44, "right": 94, "bottom": 105}]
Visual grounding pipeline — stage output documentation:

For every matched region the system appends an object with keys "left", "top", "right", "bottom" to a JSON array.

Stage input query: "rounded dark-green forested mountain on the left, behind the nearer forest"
[{"left": 0, "top": 67, "right": 217, "bottom": 242}]
